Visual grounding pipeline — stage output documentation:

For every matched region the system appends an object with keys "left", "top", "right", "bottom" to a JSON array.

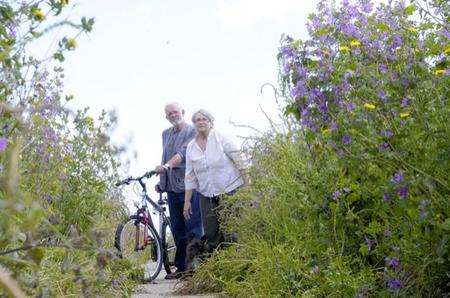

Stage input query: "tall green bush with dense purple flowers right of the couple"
[{"left": 180, "top": 0, "right": 450, "bottom": 297}]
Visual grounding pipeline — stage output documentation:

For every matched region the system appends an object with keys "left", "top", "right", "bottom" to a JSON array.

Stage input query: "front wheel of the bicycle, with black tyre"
[{"left": 115, "top": 215, "right": 163, "bottom": 281}]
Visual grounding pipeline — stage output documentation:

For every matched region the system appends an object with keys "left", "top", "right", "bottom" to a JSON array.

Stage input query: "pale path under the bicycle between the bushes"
[{"left": 131, "top": 274, "right": 214, "bottom": 298}]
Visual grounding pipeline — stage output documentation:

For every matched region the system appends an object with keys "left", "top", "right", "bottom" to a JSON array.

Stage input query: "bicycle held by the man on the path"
[{"left": 114, "top": 171, "right": 176, "bottom": 282}]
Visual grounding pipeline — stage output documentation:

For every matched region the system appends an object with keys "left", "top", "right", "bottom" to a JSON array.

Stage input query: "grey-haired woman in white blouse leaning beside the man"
[{"left": 183, "top": 110, "right": 248, "bottom": 251}]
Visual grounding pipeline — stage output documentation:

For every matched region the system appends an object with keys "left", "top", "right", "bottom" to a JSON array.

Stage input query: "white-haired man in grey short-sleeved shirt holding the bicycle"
[{"left": 155, "top": 102, "right": 202, "bottom": 279}]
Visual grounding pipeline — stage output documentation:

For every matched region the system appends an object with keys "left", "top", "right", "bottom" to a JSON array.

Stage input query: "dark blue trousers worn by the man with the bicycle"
[{"left": 167, "top": 191, "right": 203, "bottom": 271}]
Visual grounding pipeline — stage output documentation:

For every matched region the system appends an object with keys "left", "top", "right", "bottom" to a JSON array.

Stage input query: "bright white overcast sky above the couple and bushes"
[{"left": 42, "top": 0, "right": 316, "bottom": 175}]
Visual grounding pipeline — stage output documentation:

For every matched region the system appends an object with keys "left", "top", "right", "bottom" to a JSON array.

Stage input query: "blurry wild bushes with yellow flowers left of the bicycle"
[{"left": 0, "top": 0, "right": 134, "bottom": 296}]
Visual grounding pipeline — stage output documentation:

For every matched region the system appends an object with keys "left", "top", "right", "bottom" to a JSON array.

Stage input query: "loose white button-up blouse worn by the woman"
[{"left": 184, "top": 129, "right": 246, "bottom": 197}]
